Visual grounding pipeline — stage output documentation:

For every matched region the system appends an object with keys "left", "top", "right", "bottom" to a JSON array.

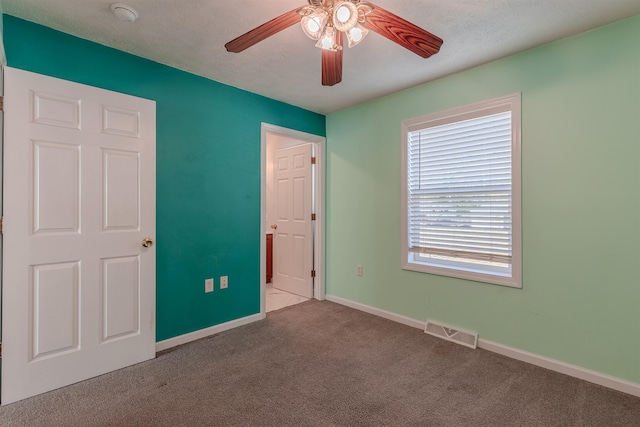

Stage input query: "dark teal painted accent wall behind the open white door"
[{"left": 4, "top": 15, "right": 325, "bottom": 341}]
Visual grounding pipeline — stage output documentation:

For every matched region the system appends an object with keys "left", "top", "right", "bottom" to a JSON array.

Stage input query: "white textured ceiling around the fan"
[{"left": 5, "top": 0, "right": 640, "bottom": 114}]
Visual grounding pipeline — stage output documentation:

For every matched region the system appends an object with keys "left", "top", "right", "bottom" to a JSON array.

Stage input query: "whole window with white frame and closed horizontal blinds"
[{"left": 402, "top": 94, "right": 522, "bottom": 287}]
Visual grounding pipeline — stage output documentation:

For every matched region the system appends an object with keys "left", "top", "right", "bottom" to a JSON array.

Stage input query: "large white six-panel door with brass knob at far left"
[{"left": 2, "top": 68, "right": 155, "bottom": 405}]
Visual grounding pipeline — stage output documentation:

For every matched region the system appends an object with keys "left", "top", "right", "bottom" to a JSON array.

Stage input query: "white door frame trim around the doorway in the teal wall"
[{"left": 260, "top": 123, "right": 327, "bottom": 319}]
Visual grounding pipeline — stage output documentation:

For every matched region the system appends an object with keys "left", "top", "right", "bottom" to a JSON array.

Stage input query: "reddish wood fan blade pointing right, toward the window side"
[{"left": 364, "top": 5, "right": 443, "bottom": 58}]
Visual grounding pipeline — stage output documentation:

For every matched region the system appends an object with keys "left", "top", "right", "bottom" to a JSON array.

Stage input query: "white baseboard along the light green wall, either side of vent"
[{"left": 326, "top": 295, "right": 640, "bottom": 397}]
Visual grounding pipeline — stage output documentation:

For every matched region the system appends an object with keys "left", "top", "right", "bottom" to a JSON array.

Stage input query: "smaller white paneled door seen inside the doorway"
[{"left": 272, "top": 144, "right": 313, "bottom": 298}]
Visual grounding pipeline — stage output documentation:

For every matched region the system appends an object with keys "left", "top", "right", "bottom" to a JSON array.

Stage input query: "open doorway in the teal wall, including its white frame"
[{"left": 260, "top": 123, "right": 326, "bottom": 317}]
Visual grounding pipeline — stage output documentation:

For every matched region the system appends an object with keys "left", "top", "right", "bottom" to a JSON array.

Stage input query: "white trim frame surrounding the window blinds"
[{"left": 401, "top": 93, "right": 522, "bottom": 288}]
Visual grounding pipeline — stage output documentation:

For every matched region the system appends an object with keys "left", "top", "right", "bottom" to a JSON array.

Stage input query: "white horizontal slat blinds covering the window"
[{"left": 407, "top": 111, "right": 513, "bottom": 264}]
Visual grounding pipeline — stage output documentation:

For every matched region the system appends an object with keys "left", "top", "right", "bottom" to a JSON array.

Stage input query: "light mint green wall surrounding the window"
[{"left": 327, "top": 15, "right": 640, "bottom": 382}]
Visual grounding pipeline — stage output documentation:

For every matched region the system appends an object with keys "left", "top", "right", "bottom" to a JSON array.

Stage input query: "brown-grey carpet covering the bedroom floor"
[{"left": 0, "top": 300, "right": 640, "bottom": 426}]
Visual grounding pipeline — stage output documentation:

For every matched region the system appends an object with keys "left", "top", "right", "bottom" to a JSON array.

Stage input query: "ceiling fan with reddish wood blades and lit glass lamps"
[{"left": 225, "top": 0, "right": 443, "bottom": 86}]
